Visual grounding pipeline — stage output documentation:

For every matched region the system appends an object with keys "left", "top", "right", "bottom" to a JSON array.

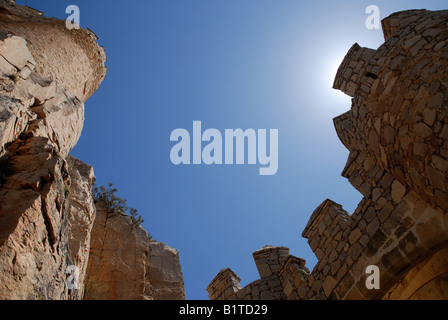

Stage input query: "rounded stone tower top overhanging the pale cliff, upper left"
[{"left": 0, "top": 0, "right": 106, "bottom": 102}]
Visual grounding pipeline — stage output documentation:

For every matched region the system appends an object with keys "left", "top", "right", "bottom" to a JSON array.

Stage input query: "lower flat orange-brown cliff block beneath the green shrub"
[{"left": 85, "top": 203, "right": 185, "bottom": 300}]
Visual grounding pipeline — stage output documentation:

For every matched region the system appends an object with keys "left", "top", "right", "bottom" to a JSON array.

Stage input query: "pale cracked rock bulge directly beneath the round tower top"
[{"left": 0, "top": 26, "right": 84, "bottom": 157}]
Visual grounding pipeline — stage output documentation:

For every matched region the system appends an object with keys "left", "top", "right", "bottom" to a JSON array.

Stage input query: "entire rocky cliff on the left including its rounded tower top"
[{"left": 0, "top": 0, "right": 185, "bottom": 299}]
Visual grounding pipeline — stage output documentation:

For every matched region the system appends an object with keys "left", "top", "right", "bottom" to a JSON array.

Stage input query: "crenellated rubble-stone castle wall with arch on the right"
[{"left": 207, "top": 10, "right": 448, "bottom": 300}]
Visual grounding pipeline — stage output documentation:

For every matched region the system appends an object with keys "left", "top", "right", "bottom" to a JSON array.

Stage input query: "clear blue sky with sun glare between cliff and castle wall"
[{"left": 17, "top": 0, "right": 446, "bottom": 300}]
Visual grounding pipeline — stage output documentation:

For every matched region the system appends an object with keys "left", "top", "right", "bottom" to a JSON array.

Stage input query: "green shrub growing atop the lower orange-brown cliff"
[{"left": 93, "top": 182, "right": 145, "bottom": 227}]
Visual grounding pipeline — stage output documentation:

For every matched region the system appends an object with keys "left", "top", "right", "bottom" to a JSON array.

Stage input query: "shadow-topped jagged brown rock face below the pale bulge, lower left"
[{"left": 0, "top": 138, "right": 77, "bottom": 299}]
